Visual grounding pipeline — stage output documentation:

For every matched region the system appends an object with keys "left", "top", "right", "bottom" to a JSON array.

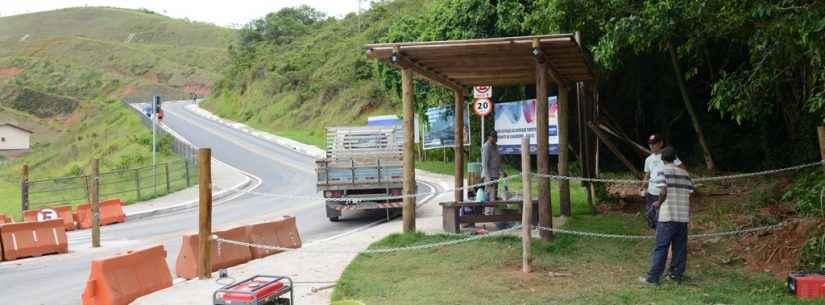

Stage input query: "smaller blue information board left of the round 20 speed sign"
[{"left": 424, "top": 107, "right": 470, "bottom": 150}]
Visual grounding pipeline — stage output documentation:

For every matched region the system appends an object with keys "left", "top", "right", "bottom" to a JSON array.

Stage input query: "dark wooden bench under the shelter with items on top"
[{"left": 438, "top": 200, "right": 539, "bottom": 233}]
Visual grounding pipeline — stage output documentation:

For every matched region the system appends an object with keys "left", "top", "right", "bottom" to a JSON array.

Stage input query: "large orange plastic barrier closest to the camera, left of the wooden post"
[{"left": 83, "top": 245, "right": 172, "bottom": 305}]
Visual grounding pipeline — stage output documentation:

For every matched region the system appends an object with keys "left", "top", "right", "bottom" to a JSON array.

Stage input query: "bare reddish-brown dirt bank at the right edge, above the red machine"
[{"left": 737, "top": 219, "right": 825, "bottom": 278}]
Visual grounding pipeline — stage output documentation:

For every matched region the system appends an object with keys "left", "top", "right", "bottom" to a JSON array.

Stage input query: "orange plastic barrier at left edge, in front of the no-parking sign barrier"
[{"left": 0, "top": 219, "right": 69, "bottom": 261}]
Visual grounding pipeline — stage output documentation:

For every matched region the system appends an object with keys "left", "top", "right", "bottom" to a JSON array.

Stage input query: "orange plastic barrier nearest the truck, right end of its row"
[{"left": 247, "top": 216, "right": 301, "bottom": 259}]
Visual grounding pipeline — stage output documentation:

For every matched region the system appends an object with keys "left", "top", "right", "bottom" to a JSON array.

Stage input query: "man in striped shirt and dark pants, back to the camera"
[{"left": 639, "top": 147, "right": 694, "bottom": 284}]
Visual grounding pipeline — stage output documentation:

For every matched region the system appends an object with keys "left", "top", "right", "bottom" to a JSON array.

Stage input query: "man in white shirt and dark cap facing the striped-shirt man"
[{"left": 641, "top": 134, "right": 685, "bottom": 229}]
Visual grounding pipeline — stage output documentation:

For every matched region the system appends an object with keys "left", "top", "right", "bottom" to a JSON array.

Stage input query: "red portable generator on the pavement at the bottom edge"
[{"left": 212, "top": 275, "right": 295, "bottom": 305}]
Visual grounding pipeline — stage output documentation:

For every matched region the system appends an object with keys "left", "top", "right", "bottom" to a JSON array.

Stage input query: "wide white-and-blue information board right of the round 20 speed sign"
[{"left": 495, "top": 96, "right": 559, "bottom": 155}]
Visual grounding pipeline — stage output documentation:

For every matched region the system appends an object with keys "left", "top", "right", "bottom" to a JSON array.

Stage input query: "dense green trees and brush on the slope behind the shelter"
[{"left": 206, "top": 0, "right": 825, "bottom": 170}]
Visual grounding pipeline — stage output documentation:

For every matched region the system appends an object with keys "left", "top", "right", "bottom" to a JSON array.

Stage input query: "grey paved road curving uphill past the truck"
[{"left": 0, "top": 103, "right": 431, "bottom": 305}]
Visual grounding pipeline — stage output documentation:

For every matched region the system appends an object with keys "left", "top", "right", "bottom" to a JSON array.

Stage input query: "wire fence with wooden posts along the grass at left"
[{"left": 22, "top": 160, "right": 198, "bottom": 210}]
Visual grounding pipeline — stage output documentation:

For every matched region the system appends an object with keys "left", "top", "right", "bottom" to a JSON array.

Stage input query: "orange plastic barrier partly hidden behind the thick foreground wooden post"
[{"left": 175, "top": 226, "right": 252, "bottom": 279}]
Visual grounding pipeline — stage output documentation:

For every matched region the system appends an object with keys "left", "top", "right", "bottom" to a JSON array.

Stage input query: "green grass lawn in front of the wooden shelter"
[{"left": 333, "top": 214, "right": 808, "bottom": 305}]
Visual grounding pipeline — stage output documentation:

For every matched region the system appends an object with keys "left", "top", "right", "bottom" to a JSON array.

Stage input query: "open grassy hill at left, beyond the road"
[{"left": 0, "top": 7, "right": 235, "bottom": 216}]
